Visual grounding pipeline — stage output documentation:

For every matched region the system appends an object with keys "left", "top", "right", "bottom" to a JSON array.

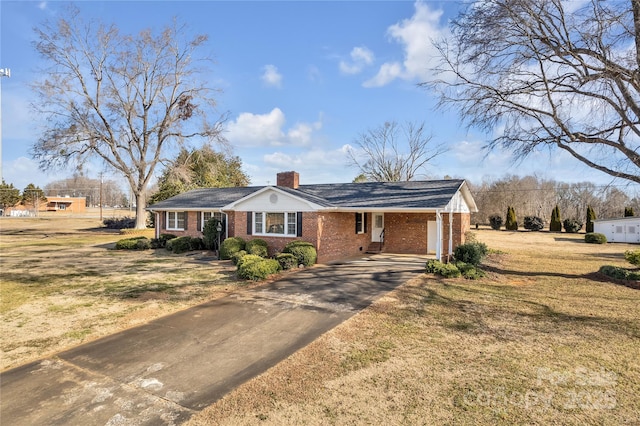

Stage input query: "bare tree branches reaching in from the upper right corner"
[{"left": 422, "top": 0, "right": 640, "bottom": 182}]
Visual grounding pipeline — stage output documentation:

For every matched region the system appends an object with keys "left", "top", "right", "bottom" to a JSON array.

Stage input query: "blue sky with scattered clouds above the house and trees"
[{"left": 0, "top": 0, "right": 632, "bottom": 189}]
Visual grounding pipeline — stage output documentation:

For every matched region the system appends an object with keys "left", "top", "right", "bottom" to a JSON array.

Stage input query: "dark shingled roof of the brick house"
[{"left": 149, "top": 179, "right": 464, "bottom": 210}]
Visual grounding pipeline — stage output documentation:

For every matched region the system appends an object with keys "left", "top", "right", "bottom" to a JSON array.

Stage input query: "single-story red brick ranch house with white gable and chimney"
[{"left": 147, "top": 171, "right": 477, "bottom": 263}]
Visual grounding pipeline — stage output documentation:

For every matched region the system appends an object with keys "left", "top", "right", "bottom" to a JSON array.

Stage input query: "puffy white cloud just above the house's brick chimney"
[{"left": 227, "top": 108, "right": 322, "bottom": 146}]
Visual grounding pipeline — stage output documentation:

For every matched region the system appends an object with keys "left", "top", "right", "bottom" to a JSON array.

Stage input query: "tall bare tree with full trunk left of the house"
[{"left": 32, "top": 9, "right": 228, "bottom": 228}]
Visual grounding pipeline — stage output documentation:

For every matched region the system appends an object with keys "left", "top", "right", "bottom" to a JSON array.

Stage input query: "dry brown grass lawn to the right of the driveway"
[{"left": 189, "top": 230, "right": 640, "bottom": 425}]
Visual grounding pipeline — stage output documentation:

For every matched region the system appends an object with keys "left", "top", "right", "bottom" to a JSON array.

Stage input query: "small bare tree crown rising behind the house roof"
[{"left": 348, "top": 122, "right": 446, "bottom": 182}]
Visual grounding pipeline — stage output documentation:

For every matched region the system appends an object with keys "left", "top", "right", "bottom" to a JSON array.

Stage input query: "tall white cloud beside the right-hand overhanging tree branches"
[{"left": 363, "top": 1, "right": 448, "bottom": 87}]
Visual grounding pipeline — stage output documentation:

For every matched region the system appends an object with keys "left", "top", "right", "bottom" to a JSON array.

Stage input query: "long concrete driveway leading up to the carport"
[{"left": 0, "top": 255, "right": 425, "bottom": 425}]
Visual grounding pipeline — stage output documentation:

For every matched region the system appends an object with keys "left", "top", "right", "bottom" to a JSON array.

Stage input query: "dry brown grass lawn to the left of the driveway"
[{"left": 0, "top": 217, "right": 246, "bottom": 370}]
